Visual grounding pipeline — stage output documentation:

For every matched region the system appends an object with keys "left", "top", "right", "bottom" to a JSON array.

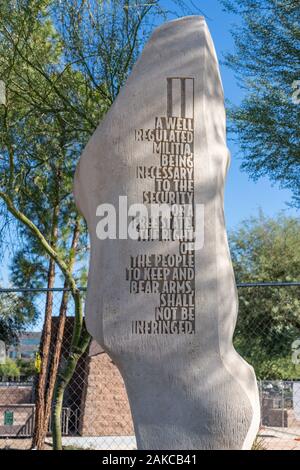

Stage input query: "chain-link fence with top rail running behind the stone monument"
[{"left": 0, "top": 283, "right": 300, "bottom": 450}]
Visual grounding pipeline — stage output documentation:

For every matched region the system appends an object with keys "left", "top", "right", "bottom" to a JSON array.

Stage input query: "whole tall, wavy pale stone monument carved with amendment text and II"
[{"left": 74, "top": 16, "right": 259, "bottom": 450}]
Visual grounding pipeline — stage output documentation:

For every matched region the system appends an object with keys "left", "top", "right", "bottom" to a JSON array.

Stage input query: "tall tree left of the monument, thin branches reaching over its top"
[{"left": 0, "top": 0, "right": 199, "bottom": 449}]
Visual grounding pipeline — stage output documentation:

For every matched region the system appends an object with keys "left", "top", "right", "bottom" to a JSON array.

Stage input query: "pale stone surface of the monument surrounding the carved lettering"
[{"left": 74, "top": 16, "right": 259, "bottom": 450}]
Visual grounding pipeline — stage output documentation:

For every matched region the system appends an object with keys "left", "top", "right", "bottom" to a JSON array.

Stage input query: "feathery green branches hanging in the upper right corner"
[{"left": 221, "top": 0, "right": 300, "bottom": 206}]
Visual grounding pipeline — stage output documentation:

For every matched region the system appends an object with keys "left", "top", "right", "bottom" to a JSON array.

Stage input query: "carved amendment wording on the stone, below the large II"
[{"left": 126, "top": 96, "right": 195, "bottom": 335}]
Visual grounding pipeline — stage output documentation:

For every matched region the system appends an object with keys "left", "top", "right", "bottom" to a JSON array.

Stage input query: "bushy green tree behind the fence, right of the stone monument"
[{"left": 230, "top": 213, "right": 300, "bottom": 380}]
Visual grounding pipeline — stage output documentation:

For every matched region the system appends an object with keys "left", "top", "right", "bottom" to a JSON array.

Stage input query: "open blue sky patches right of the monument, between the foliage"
[{"left": 161, "top": 0, "right": 296, "bottom": 229}]
